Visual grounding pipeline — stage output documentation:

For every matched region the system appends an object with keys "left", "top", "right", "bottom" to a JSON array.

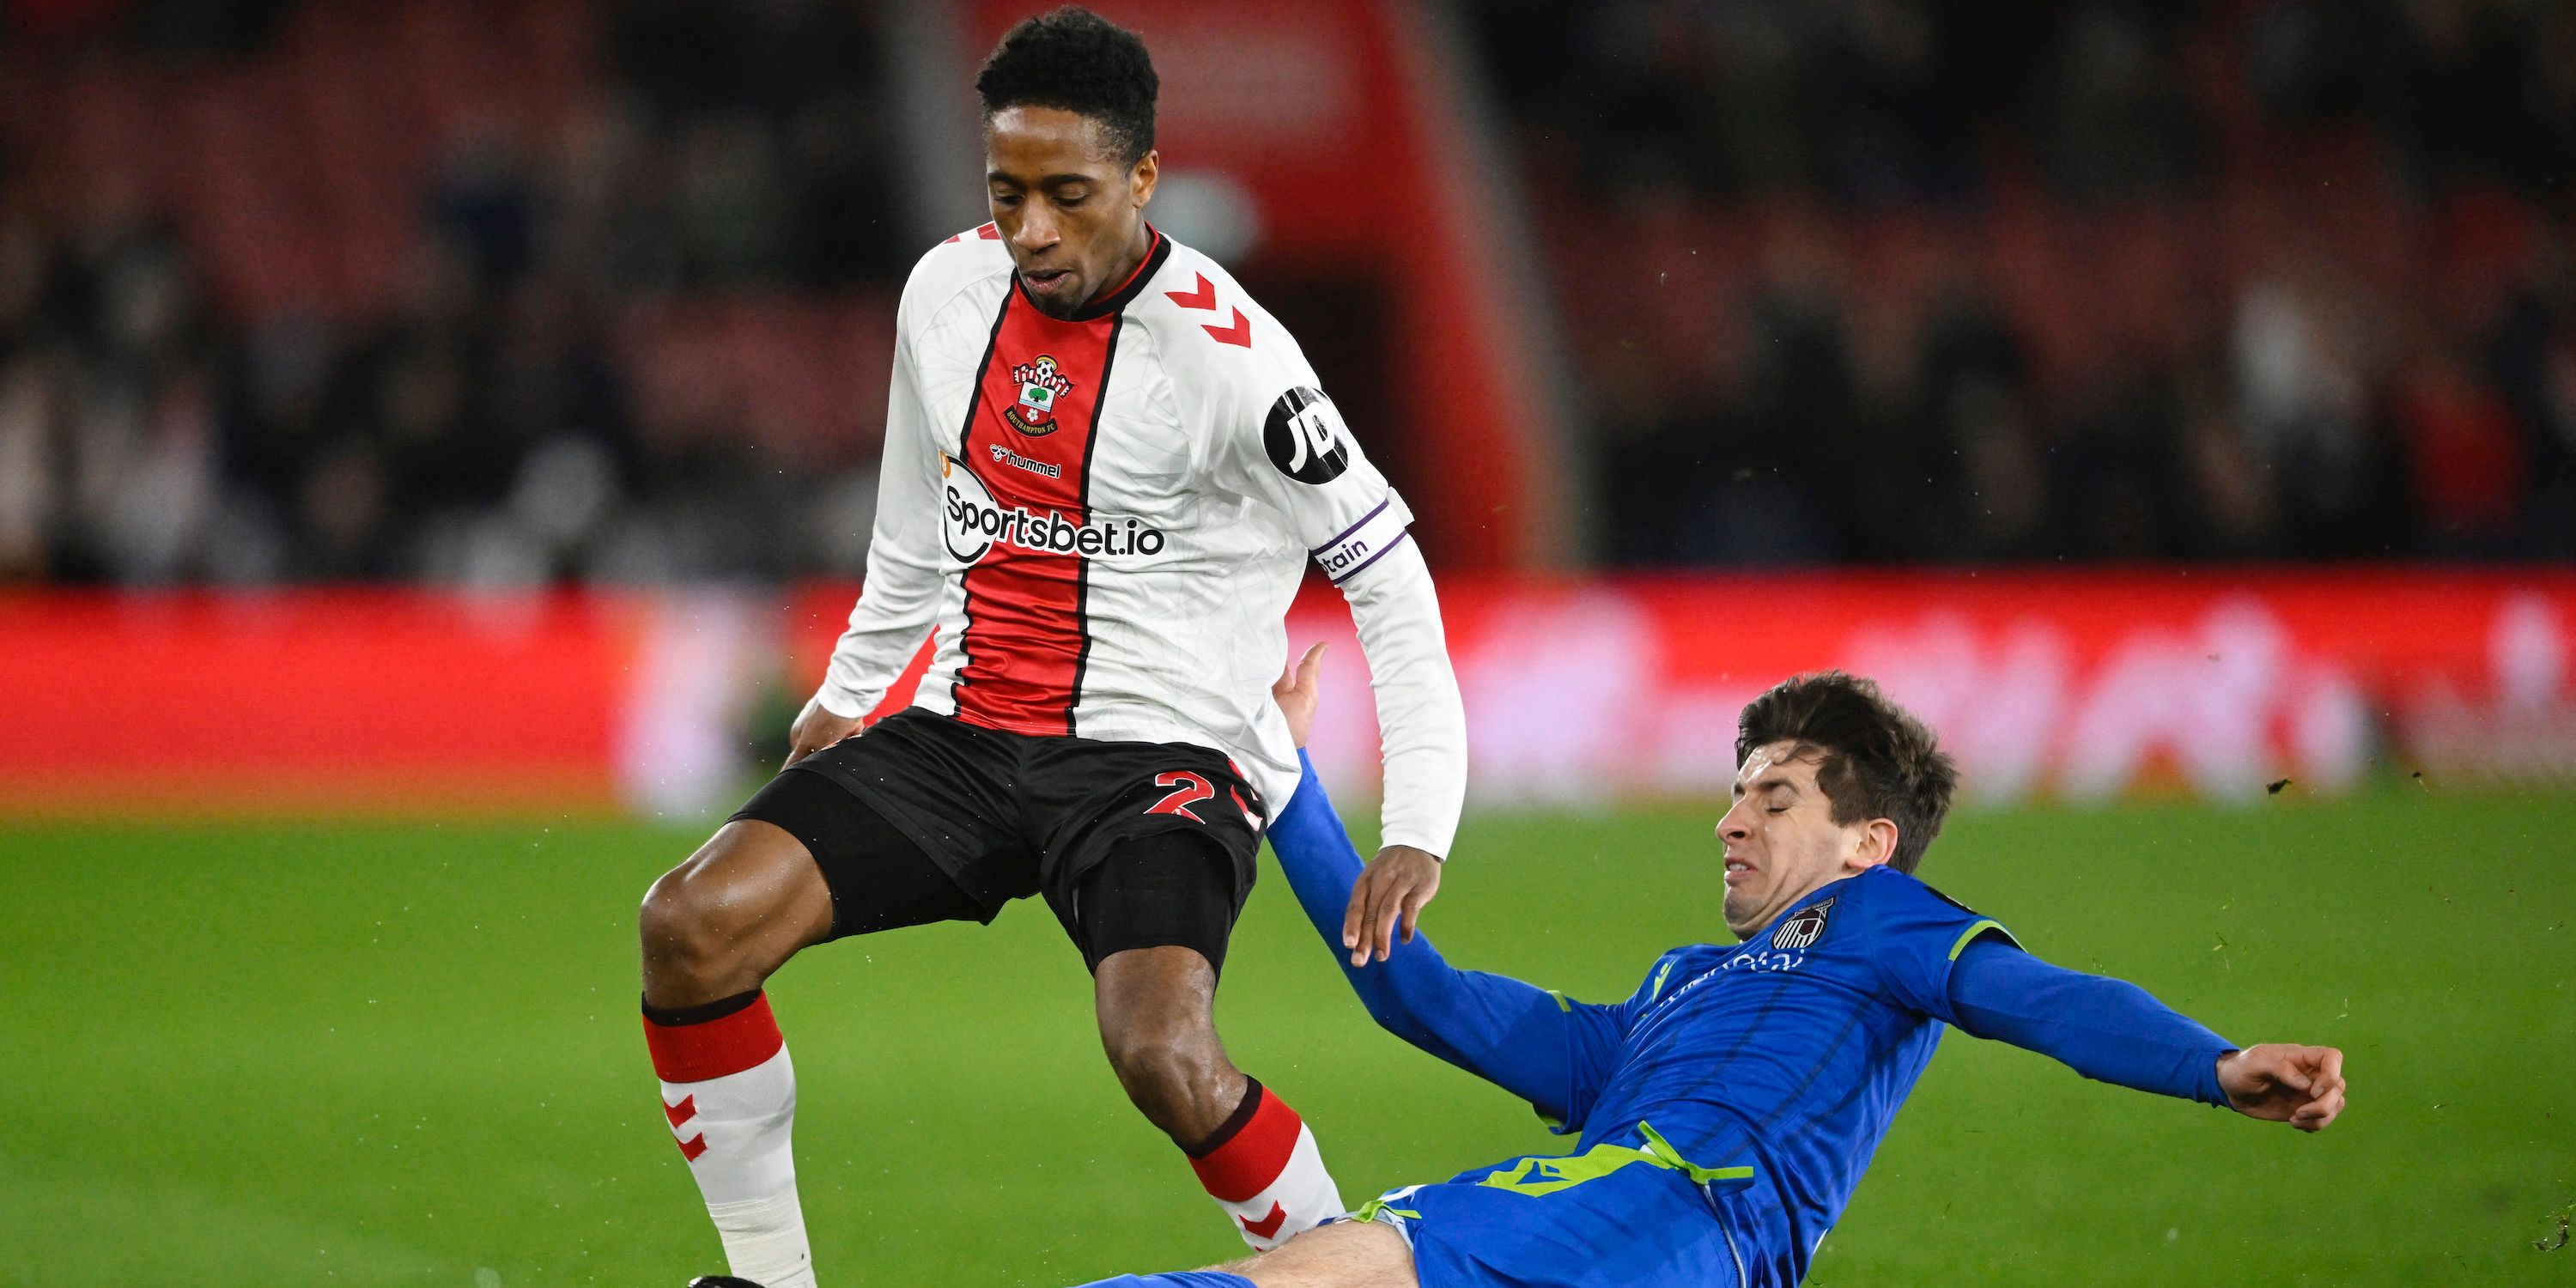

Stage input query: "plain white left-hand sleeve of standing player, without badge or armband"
[{"left": 814, "top": 252, "right": 945, "bottom": 719}]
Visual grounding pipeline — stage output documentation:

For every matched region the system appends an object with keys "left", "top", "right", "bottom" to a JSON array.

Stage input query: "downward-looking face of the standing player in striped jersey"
[{"left": 984, "top": 108, "right": 1159, "bottom": 317}]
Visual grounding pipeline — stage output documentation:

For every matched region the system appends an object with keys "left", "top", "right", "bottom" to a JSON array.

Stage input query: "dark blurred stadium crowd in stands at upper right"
[{"left": 1468, "top": 0, "right": 2576, "bottom": 564}]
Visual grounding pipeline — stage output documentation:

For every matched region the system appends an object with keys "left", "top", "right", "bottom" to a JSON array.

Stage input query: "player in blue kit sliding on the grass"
[{"left": 1056, "top": 652, "right": 2344, "bottom": 1288}]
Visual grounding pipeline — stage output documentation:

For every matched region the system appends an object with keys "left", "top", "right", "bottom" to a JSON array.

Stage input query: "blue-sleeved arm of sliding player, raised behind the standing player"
[{"left": 1270, "top": 652, "right": 1618, "bottom": 1118}]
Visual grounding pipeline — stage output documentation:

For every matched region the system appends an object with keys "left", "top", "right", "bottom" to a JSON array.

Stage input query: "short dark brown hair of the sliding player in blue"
[{"left": 1736, "top": 670, "right": 1958, "bottom": 873}]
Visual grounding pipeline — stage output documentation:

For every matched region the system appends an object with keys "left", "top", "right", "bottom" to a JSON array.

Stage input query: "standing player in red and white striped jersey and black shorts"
[{"left": 641, "top": 8, "right": 1466, "bottom": 1288}]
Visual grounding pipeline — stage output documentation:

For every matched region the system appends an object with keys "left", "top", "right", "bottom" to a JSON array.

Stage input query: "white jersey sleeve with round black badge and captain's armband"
[{"left": 1200, "top": 314, "right": 1466, "bottom": 858}]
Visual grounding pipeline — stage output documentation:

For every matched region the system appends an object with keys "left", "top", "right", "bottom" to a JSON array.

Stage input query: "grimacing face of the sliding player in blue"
[{"left": 1718, "top": 742, "right": 1893, "bottom": 938}]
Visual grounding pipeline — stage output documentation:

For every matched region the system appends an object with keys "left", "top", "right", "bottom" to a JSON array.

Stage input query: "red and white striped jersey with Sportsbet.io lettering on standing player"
[{"left": 817, "top": 224, "right": 1466, "bottom": 855}]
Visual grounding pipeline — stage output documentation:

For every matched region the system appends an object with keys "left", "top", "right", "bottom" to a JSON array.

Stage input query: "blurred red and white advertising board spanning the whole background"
[{"left": 0, "top": 569, "right": 2576, "bottom": 819}]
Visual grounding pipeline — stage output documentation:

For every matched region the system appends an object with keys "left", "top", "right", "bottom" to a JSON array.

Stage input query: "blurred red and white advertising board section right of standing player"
[{"left": 1267, "top": 569, "right": 2576, "bottom": 804}]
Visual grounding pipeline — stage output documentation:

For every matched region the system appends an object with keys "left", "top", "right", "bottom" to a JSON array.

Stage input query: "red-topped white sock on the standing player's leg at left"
[{"left": 644, "top": 992, "right": 814, "bottom": 1288}]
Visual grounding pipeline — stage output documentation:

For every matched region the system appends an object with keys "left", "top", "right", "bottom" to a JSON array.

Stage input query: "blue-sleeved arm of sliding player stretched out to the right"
[{"left": 1950, "top": 938, "right": 2344, "bottom": 1131}]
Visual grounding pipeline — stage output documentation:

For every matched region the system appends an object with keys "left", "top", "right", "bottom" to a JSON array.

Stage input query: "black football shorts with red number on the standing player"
[{"left": 734, "top": 708, "right": 1262, "bottom": 969}]
